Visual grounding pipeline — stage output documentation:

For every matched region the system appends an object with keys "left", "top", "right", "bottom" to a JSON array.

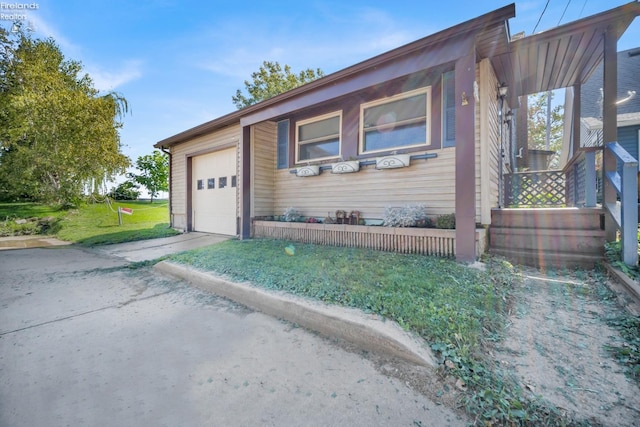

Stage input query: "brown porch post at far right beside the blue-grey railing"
[{"left": 602, "top": 28, "right": 618, "bottom": 242}]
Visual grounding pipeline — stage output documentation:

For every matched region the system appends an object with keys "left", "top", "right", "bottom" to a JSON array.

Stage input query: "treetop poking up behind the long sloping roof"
[{"left": 231, "top": 61, "right": 324, "bottom": 109}]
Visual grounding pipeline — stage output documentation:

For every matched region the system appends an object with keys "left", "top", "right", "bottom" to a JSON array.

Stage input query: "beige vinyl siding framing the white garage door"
[{"left": 171, "top": 124, "right": 242, "bottom": 230}]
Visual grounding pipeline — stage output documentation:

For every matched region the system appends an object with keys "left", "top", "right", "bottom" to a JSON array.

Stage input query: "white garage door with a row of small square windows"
[{"left": 191, "top": 148, "right": 237, "bottom": 235}]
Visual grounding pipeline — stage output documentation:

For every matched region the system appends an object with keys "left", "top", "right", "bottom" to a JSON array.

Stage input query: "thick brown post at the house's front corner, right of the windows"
[{"left": 455, "top": 49, "right": 476, "bottom": 262}]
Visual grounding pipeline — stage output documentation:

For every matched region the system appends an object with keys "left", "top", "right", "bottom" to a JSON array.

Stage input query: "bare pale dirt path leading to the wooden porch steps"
[{"left": 495, "top": 270, "right": 640, "bottom": 426}]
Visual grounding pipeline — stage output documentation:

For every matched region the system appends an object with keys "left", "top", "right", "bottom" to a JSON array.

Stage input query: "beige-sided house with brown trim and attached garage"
[{"left": 155, "top": 2, "right": 640, "bottom": 261}]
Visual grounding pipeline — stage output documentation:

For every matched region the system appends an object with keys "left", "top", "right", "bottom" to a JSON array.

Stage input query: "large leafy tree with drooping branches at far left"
[{"left": 0, "top": 28, "right": 129, "bottom": 204}]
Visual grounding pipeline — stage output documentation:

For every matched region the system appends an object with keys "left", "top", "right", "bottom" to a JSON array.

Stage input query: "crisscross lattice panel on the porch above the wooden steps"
[{"left": 504, "top": 171, "right": 566, "bottom": 207}]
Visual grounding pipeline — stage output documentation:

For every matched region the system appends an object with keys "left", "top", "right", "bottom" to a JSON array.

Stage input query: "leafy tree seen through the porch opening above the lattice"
[{"left": 527, "top": 92, "right": 564, "bottom": 168}]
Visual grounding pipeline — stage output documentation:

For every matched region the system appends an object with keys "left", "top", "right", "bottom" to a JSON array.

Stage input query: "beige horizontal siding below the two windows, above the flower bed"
[{"left": 274, "top": 149, "right": 455, "bottom": 219}]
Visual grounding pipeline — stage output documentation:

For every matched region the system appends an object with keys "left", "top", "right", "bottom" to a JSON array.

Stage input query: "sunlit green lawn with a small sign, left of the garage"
[{"left": 57, "top": 201, "right": 178, "bottom": 245}]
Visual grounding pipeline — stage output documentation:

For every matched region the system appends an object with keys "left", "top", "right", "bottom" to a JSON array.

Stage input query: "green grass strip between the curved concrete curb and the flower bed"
[{"left": 171, "top": 239, "right": 562, "bottom": 425}]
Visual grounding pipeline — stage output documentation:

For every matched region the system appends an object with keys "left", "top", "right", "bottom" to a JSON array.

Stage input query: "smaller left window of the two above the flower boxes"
[{"left": 296, "top": 111, "right": 342, "bottom": 163}]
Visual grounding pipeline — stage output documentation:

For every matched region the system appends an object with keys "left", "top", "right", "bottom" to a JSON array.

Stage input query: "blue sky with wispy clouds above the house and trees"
[{"left": 0, "top": 0, "right": 640, "bottom": 167}]
